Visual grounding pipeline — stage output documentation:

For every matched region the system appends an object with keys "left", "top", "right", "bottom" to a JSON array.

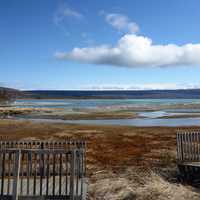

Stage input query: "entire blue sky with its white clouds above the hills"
[{"left": 0, "top": 0, "right": 200, "bottom": 89}]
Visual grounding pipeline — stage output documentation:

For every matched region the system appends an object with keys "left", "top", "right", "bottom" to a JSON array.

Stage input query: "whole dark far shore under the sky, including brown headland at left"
[{"left": 0, "top": 87, "right": 200, "bottom": 100}]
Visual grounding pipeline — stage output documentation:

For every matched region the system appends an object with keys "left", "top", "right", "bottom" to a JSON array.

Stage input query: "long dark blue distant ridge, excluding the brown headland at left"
[{"left": 23, "top": 89, "right": 200, "bottom": 99}]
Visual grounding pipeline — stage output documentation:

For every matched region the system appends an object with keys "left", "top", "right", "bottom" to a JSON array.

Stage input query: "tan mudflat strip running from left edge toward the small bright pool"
[{"left": 0, "top": 107, "right": 138, "bottom": 120}]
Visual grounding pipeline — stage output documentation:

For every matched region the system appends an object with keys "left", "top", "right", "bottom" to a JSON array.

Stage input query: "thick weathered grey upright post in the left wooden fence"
[{"left": 13, "top": 150, "right": 21, "bottom": 200}]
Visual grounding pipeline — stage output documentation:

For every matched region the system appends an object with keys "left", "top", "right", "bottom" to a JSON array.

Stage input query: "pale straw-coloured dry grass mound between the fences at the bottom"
[{"left": 89, "top": 169, "right": 200, "bottom": 200}]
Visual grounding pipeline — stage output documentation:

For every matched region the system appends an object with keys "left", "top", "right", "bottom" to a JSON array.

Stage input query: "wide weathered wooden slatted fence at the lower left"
[{"left": 0, "top": 141, "right": 86, "bottom": 200}]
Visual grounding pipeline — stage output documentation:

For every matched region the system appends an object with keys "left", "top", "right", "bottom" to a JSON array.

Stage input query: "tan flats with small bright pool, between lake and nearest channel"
[{"left": 0, "top": 104, "right": 200, "bottom": 120}]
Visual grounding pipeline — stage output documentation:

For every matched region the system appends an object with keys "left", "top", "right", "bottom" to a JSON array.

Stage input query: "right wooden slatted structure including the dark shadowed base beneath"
[{"left": 177, "top": 131, "right": 200, "bottom": 183}]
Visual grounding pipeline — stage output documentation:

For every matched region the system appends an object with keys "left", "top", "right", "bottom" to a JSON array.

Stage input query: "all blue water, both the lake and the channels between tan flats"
[{"left": 11, "top": 99, "right": 200, "bottom": 126}]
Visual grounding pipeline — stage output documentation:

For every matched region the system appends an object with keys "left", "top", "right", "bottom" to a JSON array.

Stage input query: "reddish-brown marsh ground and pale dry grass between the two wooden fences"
[{"left": 0, "top": 120, "right": 200, "bottom": 200}]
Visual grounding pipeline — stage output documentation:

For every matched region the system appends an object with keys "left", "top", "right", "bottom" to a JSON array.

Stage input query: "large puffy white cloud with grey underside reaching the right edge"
[{"left": 55, "top": 34, "right": 200, "bottom": 68}]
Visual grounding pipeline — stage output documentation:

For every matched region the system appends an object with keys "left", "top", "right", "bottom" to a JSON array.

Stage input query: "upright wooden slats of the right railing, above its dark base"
[{"left": 176, "top": 131, "right": 200, "bottom": 162}]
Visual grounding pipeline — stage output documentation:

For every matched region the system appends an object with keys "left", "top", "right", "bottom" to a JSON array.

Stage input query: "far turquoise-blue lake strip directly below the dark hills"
[{"left": 14, "top": 99, "right": 200, "bottom": 111}]
